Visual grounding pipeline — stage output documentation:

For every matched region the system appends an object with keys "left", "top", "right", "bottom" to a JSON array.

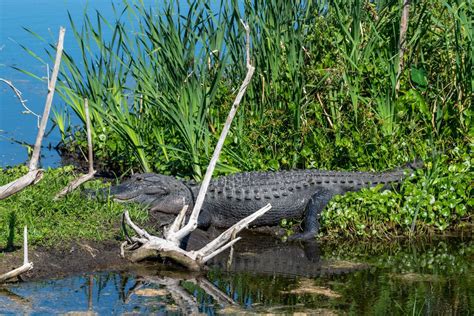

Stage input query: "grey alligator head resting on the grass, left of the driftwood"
[{"left": 105, "top": 173, "right": 193, "bottom": 214}]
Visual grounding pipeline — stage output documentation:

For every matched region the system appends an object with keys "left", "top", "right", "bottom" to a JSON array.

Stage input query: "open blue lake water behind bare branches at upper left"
[{"left": 0, "top": 0, "right": 180, "bottom": 167}]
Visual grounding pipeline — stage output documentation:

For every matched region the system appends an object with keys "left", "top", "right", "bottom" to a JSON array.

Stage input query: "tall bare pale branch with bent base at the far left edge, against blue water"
[{"left": 0, "top": 27, "right": 66, "bottom": 200}]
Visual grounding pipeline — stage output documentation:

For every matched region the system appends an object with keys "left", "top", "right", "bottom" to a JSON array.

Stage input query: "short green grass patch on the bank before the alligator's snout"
[{"left": 0, "top": 166, "right": 147, "bottom": 249}]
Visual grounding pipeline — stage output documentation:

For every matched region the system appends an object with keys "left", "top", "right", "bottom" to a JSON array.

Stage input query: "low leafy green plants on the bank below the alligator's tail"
[{"left": 322, "top": 148, "right": 474, "bottom": 239}]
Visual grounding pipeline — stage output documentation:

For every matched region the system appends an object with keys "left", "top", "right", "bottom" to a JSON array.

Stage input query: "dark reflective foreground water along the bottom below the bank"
[{"left": 0, "top": 239, "right": 474, "bottom": 315}]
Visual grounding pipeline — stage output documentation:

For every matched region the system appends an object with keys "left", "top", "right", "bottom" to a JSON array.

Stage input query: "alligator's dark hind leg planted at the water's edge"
[{"left": 288, "top": 188, "right": 334, "bottom": 240}]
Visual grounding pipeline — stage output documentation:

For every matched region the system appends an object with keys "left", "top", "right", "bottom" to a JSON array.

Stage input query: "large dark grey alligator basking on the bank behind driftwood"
[{"left": 99, "top": 163, "right": 418, "bottom": 239}]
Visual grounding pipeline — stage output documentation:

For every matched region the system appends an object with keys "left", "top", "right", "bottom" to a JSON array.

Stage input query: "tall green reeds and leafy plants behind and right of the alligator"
[{"left": 11, "top": 0, "right": 474, "bottom": 238}]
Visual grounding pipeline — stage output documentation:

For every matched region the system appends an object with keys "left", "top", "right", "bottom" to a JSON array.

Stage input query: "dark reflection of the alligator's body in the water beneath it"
[{"left": 186, "top": 230, "right": 368, "bottom": 277}]
